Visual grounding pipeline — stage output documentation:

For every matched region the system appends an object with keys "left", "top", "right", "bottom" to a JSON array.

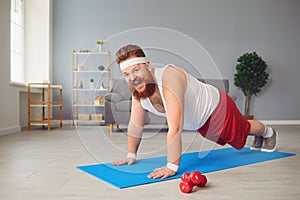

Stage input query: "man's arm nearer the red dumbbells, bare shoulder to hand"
[{"left": 148, "top": 67, "right": 187, "bottom": 178}]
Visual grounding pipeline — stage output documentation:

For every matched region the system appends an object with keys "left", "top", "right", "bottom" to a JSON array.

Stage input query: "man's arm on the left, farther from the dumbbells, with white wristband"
[{"left": 112, "top": 97, "right": 146, "bottom": 165}]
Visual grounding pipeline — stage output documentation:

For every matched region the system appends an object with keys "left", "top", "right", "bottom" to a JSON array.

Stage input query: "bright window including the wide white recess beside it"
[{"left": 10, "top": 0, "right": 52, "bottom": 85}]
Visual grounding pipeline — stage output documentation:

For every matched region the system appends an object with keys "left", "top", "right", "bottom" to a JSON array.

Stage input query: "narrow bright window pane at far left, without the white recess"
[{"left": 10, "top": 0, "right": 25, "bottom": 84}]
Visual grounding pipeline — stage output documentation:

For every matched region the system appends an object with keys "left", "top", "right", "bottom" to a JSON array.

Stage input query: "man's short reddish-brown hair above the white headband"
[{"left": 116, "top": 44, "right": 146, "bottom": 64}]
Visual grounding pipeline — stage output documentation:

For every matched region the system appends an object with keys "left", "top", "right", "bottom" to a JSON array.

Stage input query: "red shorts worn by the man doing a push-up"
[{"left": 198, "top": 91, "right": 250, "bottom": 149}]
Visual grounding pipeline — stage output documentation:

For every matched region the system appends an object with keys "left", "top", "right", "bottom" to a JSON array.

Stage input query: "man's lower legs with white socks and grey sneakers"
[{"left": 248, "top": 120, "right": 278, "bottom": 152}]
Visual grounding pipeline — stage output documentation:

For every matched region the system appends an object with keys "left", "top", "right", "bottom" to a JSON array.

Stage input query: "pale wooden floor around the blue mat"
[{"left": 0, "top": 125, "right": 300, "bottom": 200}]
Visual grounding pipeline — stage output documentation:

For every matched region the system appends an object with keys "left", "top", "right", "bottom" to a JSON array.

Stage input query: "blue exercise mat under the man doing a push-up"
[{"left": 77, "top": 148, "right": 295, "bottom": 188}]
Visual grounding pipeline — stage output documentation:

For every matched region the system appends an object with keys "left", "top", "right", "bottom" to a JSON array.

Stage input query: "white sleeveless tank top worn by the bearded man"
[{"left": 141, "top": 65, "right": 220, "bottom": 130}]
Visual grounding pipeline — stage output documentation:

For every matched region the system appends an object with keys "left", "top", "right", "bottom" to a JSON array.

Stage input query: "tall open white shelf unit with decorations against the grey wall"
[{"left": 72, "top": 51, "right": 111, "bottom": 125}]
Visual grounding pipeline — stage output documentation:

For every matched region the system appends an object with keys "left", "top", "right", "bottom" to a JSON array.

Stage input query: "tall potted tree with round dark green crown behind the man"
[{"left": 234, "top": 51, "right": 269, "bottom": 119}]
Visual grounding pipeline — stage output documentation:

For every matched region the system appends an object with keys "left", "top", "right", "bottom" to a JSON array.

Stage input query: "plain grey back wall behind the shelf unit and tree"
[{"left": 53, "top": 0, "right": 300, "bottom": 120}]
